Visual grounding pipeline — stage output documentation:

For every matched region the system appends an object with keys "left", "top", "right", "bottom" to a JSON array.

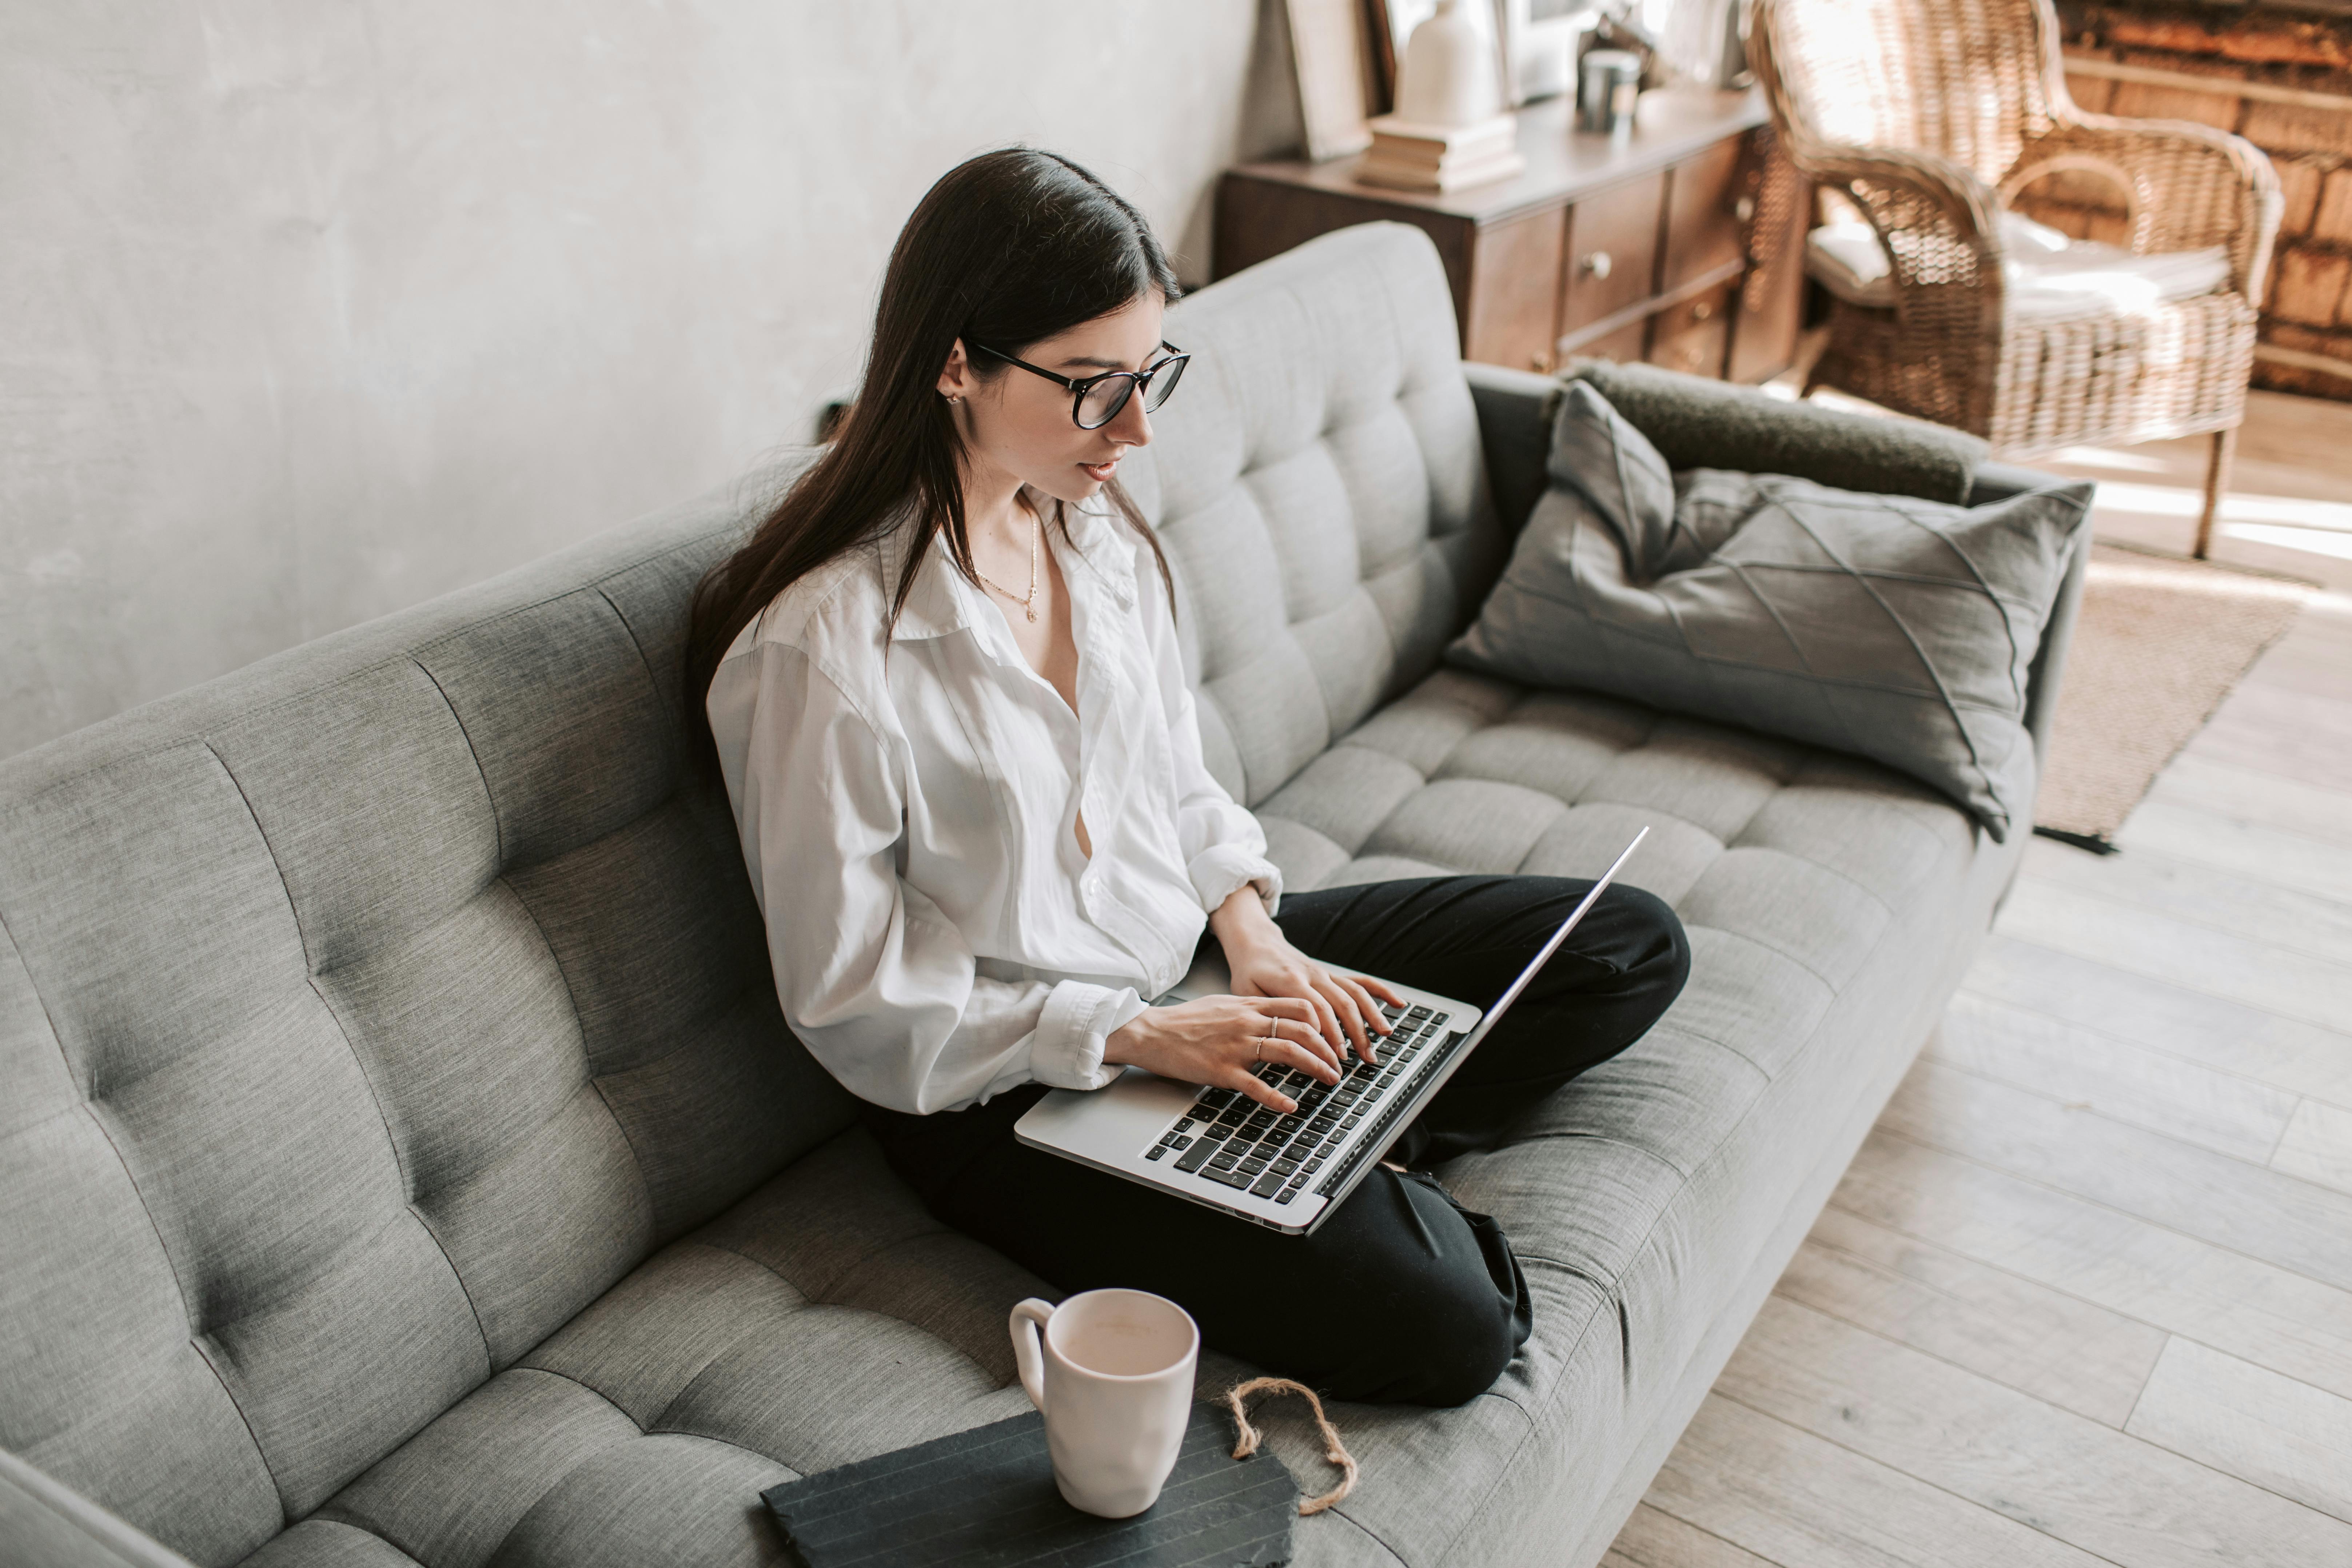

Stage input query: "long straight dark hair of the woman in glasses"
[{"left": 687, "top": 148, "right": 1176, "bottom": 764}]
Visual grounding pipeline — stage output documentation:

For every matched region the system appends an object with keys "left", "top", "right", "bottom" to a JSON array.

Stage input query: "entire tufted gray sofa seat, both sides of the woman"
[{"left": 249, "top": 670, "right": 1983, "bottom": 1568}]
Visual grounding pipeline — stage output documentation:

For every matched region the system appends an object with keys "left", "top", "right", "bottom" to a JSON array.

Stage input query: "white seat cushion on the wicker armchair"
[{"left": 1804, "top": 212, "right": 2230, "bottom": 324}]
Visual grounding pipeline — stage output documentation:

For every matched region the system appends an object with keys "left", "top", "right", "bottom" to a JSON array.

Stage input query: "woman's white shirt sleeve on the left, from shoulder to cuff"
[{"left": 708, "top": 642, "right": 1129, "bottom": 1114}]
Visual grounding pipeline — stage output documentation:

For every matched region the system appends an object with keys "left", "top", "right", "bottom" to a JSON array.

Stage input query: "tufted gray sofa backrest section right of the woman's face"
[{"left": 1129, "top": 223, "right": 1508, "bottom": 806}]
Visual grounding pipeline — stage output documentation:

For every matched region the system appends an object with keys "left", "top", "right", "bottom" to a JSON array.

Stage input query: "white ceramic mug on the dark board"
[{"left": 1011, "top": 1290, "right": 1200, "bottom": 1519}]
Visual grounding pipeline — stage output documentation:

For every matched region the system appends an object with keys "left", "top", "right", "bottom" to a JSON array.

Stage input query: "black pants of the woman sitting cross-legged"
[{"left": 865, "top": 877, "right": 1691, "bottom": 1406}]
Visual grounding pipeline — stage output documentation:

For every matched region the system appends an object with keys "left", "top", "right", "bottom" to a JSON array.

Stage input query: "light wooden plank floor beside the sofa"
[{"left": 1604, "top": 395, "right": 2352, "bottom": 1568}]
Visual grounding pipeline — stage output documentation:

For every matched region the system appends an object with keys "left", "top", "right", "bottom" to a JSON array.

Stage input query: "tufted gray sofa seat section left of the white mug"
[{"left": 247, "top": 1128, "right": 1056, "bottom": 1568}]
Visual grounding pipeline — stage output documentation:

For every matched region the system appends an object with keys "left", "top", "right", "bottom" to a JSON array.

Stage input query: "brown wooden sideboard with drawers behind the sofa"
[{"left": 1213, "top": 87, "right": 1809, "bottom": 381}]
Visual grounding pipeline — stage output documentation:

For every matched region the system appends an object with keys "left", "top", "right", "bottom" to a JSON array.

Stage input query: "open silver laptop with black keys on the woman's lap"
[{"left": 1014, "top": 827, "right": 1649, "bottom": 1234}]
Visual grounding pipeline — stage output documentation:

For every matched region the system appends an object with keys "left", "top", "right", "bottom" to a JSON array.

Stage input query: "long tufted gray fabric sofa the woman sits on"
[{"left": 0, "top": 226, "right": 2079, "bottom": 1568}]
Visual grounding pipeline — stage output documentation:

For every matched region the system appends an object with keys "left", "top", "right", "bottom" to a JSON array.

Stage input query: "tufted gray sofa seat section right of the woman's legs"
[{"left": 1258, "top": 670, "right": 2013, "bottom": 1563}]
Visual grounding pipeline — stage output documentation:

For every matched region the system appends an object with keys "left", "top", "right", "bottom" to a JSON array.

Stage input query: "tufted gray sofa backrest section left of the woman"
[{"left": 0, "top": 472, "right": 852, "bottom": 1561}]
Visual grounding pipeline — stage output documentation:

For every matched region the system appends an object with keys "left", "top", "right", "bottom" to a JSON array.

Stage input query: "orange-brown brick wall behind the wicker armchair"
[{"left": 2018, "top": 0, "right": 2352, "bottom": 400}]
